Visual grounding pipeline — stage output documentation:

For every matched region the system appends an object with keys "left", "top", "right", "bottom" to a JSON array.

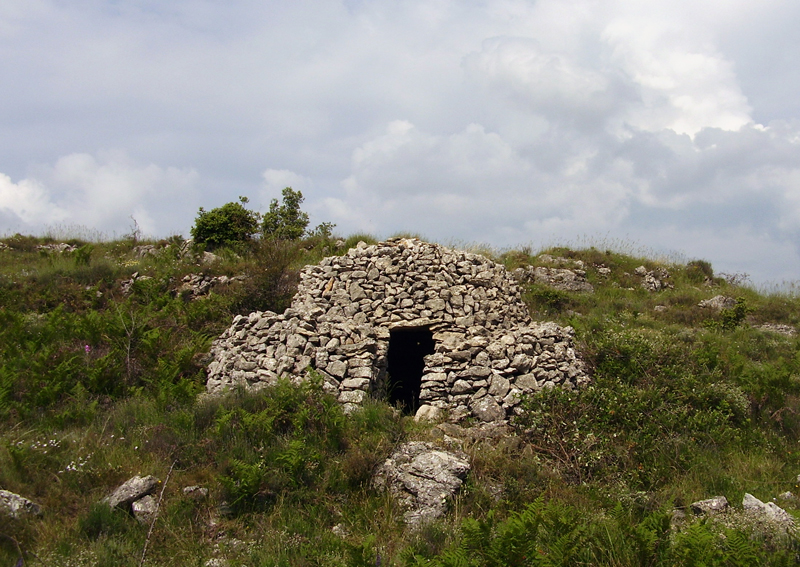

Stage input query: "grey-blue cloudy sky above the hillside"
[{"left": 0, "top": 0, "right": 800, "bottom": 282}]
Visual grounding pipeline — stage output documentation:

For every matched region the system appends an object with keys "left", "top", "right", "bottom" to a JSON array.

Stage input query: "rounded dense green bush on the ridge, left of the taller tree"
[{"left": 192, "top": 197, "right": 260, "bottom": 248}]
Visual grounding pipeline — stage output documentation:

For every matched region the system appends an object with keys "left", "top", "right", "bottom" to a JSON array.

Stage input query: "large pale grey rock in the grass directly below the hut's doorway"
[{"left": 373, "top": 441, "right": 470, "bottom": 526}]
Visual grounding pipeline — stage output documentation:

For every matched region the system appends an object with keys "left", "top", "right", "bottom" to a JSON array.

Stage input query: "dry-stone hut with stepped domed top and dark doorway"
[{"left": 207, "top": 238, "right": 589, "bottom": 422}]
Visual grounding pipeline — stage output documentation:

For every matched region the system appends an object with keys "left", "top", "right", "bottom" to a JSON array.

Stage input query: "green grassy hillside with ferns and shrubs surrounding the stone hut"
[{"left": 0, "top": 234, "right": 800, "bottom": 567}]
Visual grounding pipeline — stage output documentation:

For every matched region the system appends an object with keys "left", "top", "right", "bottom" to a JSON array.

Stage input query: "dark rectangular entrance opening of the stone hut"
[{"left": 387, "top": 328, "right": 434, "bottom": 413}]
